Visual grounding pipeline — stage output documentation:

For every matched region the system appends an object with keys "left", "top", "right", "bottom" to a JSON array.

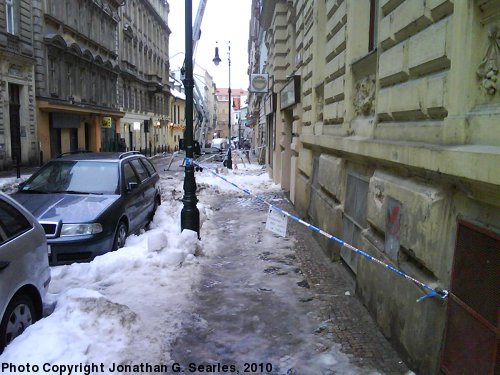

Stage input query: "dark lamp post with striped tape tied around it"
[{"left": 181, "top": 0, "right": 200, "bottom": 238}]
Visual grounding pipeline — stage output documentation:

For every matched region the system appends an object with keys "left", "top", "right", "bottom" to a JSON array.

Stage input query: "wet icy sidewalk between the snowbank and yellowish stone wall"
[{"left": 164, "top": 161, "right": 408, "bottom": 375}]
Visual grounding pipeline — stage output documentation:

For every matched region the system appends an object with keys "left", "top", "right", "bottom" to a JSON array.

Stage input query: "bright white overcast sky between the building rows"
[{"left": 168, "top": 0, "right": 252, "bottom": 90}]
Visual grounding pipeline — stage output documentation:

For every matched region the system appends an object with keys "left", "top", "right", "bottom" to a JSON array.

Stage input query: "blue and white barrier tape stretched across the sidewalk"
[{"left": 191, "top": 160, "right": 449, "bottom": 302}]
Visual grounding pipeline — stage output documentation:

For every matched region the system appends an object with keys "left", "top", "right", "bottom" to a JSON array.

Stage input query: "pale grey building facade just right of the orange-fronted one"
[{"left": 117, "top": 0, "right": 171, "bottom": 155}]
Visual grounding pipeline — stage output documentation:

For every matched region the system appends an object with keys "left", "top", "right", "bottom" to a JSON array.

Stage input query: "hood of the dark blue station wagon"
[{"left": 12, "top": 193, "right": 119, "bottom": 223}]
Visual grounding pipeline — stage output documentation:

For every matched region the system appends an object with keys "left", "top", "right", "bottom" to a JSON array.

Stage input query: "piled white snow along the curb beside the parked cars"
[{"left": 0, "top": 164, "right": 279, "bottom": 374}]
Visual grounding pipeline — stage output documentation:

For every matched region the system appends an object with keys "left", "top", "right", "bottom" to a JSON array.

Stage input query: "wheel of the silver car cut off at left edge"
[{"left": 0, "top": 294, "right": 38, "bottom": 354}]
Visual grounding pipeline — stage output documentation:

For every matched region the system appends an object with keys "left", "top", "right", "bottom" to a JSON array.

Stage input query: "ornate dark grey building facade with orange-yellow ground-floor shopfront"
[{"left": 32, "top": 0, "right": 124, "bottom": 161}]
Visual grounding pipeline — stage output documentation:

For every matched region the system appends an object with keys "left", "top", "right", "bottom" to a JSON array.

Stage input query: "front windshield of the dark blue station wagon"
[{"left": 21, "top": 161, "right": 118, "bottom": 194}]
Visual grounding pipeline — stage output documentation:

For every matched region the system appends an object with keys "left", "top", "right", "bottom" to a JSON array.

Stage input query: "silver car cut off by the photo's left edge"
[{"left": 0, "top": 193, "right": 50, "bottom": 354}]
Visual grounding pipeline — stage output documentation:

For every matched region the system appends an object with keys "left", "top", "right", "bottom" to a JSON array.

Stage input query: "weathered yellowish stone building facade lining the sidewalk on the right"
[{"left": 249, "top": 0, "right": 500, "bottom": 374}]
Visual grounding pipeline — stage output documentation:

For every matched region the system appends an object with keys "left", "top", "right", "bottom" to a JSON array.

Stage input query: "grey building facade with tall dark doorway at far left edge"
[{"left": 0, "top": 0, "right": 39, "bottom": 169}]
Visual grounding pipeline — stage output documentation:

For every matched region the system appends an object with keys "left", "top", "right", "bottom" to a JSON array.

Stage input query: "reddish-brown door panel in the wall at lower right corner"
[{"left": 441, "top": 221, "right": 500, "bottom": 375}]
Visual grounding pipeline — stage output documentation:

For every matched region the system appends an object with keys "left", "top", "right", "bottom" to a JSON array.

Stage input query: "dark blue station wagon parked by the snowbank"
[{"left": 12, "top": 151, "right": 161, "bottom": 264}]
